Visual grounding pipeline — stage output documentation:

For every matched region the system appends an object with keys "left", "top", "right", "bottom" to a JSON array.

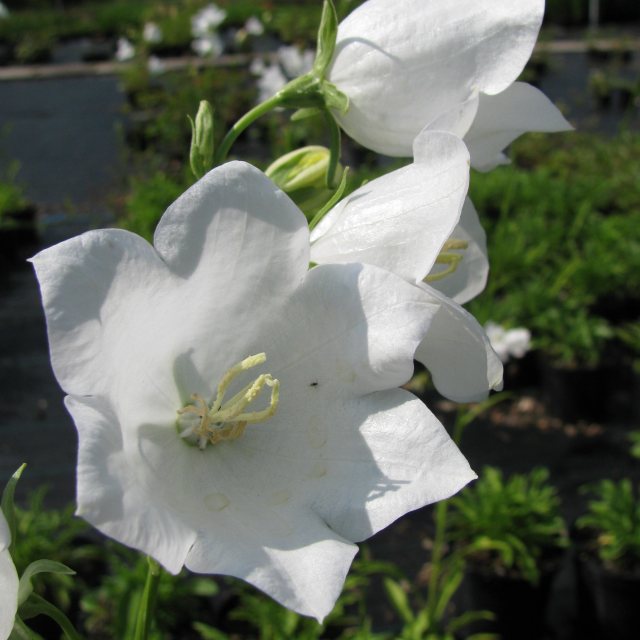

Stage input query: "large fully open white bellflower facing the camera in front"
[{"left": 32, "top": 162, "right": 474, "bottom": 619}]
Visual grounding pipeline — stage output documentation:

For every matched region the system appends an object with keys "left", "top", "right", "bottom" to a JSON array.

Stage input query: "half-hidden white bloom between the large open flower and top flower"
[{"left": 311, "top": 131, "right": 502, "bottom": 402}]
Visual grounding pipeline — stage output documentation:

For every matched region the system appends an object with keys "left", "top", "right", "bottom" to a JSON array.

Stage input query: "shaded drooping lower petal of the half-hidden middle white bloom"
[{"left": 416, "top": 284, "right": 502, "bottom": 402}]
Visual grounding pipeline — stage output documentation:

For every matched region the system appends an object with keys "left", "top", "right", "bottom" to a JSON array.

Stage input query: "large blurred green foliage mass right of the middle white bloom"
[{"left": 470, "top": 133, "right": 640, "bottom": 367}]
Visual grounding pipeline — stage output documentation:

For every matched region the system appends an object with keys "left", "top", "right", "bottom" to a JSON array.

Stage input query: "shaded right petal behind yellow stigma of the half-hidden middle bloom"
[{"left": 429, "top": 198, "right": 489, "bottom": 304}]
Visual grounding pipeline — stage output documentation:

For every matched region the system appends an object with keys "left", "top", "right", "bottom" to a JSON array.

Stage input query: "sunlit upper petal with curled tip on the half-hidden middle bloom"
[{"left": 311, "top": 131, "right": 469, "bottom": 281}]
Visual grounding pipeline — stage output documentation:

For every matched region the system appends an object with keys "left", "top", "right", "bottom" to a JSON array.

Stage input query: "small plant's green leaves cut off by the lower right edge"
[{"left": 577, "top": 478, "right": 640, "bottom": 571}]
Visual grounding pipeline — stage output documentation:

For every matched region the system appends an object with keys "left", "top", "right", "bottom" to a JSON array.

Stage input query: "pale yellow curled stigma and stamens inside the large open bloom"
[{"left": 178, "top": 353, "right": 280, "bottom": 449}]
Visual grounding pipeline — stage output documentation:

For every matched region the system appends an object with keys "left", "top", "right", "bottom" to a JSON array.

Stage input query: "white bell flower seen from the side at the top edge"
[{"left": 328, "top": 0, "right": 571, "bottom": 169}]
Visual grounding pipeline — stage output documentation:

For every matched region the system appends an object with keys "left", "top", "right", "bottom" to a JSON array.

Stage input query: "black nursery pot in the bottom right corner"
[{"left": 575, "top": 553, "right": 640, "bottom": 640}]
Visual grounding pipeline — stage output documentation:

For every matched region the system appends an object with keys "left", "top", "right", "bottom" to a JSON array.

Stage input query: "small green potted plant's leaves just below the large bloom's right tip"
[{"left": 450, "top": 467, "right": 567, "bottom": 583}]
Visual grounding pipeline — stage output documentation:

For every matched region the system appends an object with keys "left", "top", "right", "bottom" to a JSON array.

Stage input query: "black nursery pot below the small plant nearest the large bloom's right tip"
[{"left": 462, "top": 565, "right": 559, "bottom": 640}]
